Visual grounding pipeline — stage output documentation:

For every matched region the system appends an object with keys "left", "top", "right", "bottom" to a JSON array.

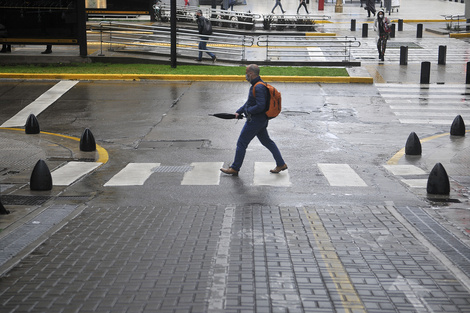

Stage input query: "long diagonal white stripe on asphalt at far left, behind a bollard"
[{"left": 0, "top": 80, "right": 78, "bottom": 127}]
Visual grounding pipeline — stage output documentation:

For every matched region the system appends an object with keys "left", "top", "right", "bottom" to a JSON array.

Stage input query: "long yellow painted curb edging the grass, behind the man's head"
[{"left": 0, "top": 73, "right": 373, "bottom": 84}]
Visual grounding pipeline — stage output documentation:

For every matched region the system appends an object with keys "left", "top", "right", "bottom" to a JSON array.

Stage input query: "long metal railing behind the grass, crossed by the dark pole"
[{"left": 99, "top": 22, "right": 254, "bottom": 61}]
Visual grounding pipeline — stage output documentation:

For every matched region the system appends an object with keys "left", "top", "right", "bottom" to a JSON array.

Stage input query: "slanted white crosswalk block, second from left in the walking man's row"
[{"left": 104, "top": 163, "right": 160, "bottom": 187}]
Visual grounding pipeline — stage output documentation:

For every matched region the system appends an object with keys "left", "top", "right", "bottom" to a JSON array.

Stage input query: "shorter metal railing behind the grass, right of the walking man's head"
[{"left": 258, "top": 35, "right": 361, "bottom": 61}]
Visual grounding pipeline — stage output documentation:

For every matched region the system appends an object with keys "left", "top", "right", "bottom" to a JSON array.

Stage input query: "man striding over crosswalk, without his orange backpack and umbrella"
[{"left": 220, "top": 64, "right": 287, "bottom": 176}]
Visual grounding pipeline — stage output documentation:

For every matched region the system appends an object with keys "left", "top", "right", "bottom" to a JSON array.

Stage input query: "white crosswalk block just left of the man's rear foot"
[{"left": 181, "top": 162, "right": 224, "bottom": 186}]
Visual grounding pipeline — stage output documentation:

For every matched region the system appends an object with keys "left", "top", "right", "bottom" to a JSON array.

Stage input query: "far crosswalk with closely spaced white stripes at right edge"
[{"left": 376, "top": 84, "right": 470, "bottom": 127}]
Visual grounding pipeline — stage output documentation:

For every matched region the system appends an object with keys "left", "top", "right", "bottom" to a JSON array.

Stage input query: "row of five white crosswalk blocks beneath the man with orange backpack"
[{"left": 46, "top": 162, "right": 368, "bottom": 188}]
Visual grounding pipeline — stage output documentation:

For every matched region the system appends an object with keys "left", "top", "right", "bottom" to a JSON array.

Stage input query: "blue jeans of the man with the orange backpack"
[{"left": 231, "top": 119, "right": 285, "bottom": 171}]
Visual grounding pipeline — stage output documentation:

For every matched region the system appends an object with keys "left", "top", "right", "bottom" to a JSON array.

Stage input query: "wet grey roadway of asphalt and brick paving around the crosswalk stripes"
[{"left": 0, "top": 81, "right": 470, "bottom": 312}]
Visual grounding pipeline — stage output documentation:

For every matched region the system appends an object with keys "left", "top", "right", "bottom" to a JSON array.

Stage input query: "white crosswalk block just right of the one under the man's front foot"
[{"left": 318, "top": 163, "right": 367, "bottom": 187}]
